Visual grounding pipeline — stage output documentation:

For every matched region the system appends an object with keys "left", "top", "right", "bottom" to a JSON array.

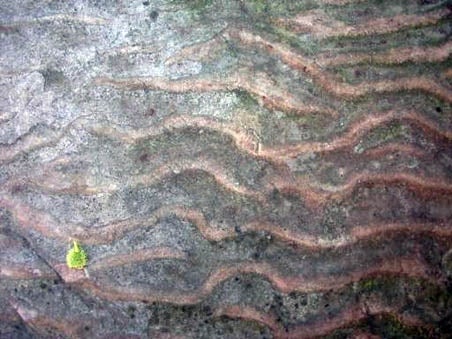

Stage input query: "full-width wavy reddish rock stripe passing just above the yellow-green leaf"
[{"left": 0, "top": 195, "right": 452, "bottom": 250}]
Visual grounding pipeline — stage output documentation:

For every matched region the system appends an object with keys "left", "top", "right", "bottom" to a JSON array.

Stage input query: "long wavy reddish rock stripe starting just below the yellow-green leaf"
[{"left": 75, "top": 258, "right": 433, "bottom": 304}]
